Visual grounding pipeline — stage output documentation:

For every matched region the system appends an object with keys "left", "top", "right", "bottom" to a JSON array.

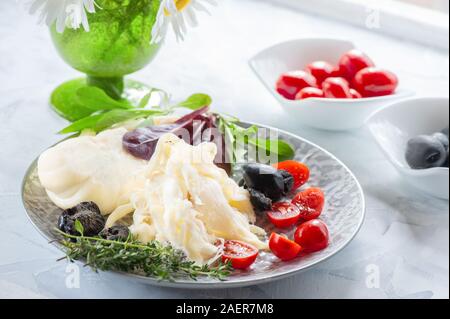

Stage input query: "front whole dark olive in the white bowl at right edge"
[{"left": 406, "top": 135, "right": 447, "bottom": 169}]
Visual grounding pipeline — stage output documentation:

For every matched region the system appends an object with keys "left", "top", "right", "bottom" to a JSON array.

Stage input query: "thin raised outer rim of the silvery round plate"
[{"left": 21, "top": 120, "right": 367, "bottom": 290}]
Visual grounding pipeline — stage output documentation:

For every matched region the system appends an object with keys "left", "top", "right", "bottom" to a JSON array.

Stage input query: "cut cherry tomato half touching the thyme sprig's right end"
[{"left": 222, "top": 240, "right": 259, "bottom": 269}]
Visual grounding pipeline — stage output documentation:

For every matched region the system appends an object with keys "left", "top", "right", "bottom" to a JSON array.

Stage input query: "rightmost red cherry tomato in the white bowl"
[{"left": 353, "top": 68, "right": 398, "bottom": 97}]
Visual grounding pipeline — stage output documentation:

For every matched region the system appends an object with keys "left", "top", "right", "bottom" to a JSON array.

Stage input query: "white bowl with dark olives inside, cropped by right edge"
[{"left": 368, "top": 98, "right": 450, "bottom": 200}]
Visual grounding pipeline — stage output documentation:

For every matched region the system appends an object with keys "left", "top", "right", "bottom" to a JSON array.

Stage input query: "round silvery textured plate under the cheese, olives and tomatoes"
[{"left": 23, "top": 123, "right": 365, "bottom": 289}]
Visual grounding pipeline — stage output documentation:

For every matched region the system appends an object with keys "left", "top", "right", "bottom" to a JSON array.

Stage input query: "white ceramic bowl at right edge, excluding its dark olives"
[{"left": 368, "top": 98, "right": 449, "bottom": 200}]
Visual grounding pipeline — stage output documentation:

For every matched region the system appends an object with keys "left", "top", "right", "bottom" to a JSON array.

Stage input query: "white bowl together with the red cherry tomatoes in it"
[{"left": 250, "top": 39, "right": 411, "bottom": 131}]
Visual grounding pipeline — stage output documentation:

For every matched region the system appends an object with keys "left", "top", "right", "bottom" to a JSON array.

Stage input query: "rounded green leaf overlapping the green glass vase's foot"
[{"left": 77, "top": 86, "right": 133, "bottom": 111}]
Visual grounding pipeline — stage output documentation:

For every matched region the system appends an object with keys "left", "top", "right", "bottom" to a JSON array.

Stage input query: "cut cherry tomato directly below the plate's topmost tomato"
[{"left": 292, "top": 187, "right": 325, "bottom": 220}]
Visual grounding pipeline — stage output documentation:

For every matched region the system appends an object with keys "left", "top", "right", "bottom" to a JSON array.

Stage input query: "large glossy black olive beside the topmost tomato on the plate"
[{"left": 242, "top": 164, "right": 285, "bottom": 201}]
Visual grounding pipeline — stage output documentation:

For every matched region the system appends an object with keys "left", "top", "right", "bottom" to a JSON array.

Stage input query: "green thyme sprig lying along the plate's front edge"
[{"left": 57, "top": 229, "right": 232, "bottom": 281}]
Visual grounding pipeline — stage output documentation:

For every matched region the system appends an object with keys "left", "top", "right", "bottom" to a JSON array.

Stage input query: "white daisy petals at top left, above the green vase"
[{"left": 30, "top": 0, "right": 96, "bottom": 33}]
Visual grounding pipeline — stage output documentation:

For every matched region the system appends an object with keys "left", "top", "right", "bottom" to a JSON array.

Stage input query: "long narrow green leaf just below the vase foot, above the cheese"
[{"left": 59, "top": 109, "right": 166, "bottom": 134}]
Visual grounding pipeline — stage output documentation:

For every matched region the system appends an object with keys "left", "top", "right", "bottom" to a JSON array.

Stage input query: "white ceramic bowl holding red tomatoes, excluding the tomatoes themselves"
[{"left": 249, "top": 39, "right": 411, "bottom": 131}]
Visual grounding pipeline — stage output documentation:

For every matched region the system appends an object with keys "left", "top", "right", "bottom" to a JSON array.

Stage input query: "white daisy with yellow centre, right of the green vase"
[{"left": 152, "top": 0, "right": 217, "bottom": 43}]
